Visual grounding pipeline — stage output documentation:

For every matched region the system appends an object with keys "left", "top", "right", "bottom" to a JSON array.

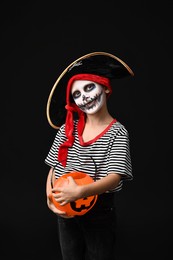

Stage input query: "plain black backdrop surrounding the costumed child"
[{"left": 0, "top": 0, "right": 173, "bottom": 260}]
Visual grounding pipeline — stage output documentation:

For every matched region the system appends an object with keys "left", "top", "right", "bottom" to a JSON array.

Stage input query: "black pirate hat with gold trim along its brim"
[{"left": 46, "top": 52, "right": 134, "bottom": 129}]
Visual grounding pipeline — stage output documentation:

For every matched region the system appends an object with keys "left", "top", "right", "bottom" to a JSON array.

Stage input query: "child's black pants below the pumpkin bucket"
[{"left": 58, "top": 194, "right": 116, "bottom": 260}]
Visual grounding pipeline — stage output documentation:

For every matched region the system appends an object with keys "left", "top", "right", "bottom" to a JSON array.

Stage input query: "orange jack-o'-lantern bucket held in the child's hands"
[{"left": 51, "top": 172, "right": 98, "bottom": 216}]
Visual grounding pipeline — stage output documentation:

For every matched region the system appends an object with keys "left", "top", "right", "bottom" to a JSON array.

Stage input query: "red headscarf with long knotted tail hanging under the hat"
[{"left": 58, "top": 74, "right": 112, "bottom": 167}]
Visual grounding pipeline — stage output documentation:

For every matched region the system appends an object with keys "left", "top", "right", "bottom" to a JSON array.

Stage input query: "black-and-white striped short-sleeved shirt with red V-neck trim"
[{"left": 45, "top": 120, "right": 133, "bottom": 192}]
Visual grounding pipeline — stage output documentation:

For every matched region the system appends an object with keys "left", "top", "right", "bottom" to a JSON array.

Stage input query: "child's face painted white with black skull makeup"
[{"left": 71, "top": 80, "right": 106, "bottom": 114}]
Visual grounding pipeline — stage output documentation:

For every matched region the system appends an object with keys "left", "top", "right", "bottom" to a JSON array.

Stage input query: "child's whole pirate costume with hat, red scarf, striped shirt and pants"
[{"left": 45, "top": 52, "right": 134, "bottom": 260}]
